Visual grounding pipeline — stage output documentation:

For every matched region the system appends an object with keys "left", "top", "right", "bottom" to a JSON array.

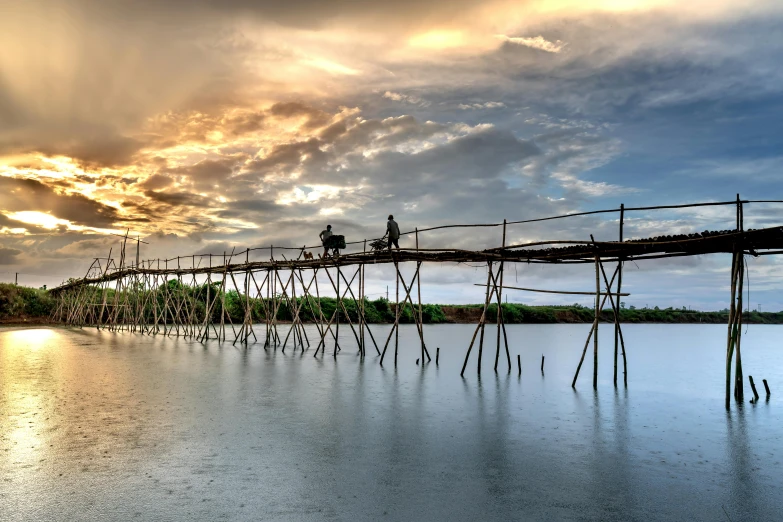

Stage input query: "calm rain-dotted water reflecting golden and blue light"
[{"left": 0, "top": 325, "right": 783, "bottom": 522}]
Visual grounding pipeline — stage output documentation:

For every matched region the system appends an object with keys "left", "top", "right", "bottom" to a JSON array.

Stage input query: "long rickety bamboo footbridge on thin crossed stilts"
[{"left": 52, "top": 196, "right": 783, "bottom": 407}]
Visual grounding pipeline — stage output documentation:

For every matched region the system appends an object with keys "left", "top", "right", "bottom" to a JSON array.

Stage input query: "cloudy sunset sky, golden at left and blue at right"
[{"left": 0, "top": 0, "right": 783, "bottom": 311}]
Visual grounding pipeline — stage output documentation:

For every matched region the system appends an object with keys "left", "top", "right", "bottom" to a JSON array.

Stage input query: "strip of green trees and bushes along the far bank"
[{"left": 0, "top": 280, "right": 783, "bottom": 324}]
